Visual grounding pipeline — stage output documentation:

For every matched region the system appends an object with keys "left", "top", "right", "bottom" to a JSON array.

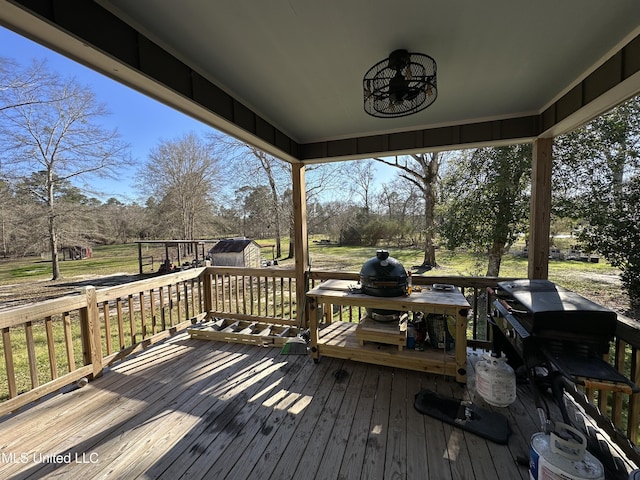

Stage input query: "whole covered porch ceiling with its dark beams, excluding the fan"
[{"left": 0, "top": 0, "right": 640, "bottom": 163}]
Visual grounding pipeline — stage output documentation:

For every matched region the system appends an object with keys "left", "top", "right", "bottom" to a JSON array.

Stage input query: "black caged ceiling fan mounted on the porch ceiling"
[{"left": 362, "top": 50, "right": 438, "bottom": 118}]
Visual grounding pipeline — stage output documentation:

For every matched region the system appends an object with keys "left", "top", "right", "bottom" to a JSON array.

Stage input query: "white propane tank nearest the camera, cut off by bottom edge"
[{"left": 529, "top": 423, "right": 604, "bottom": 480}]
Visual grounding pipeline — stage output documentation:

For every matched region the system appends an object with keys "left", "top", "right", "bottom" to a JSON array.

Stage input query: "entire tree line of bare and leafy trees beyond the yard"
[{"left": 0, "top": 59, "right": 640, "bottom": 312}]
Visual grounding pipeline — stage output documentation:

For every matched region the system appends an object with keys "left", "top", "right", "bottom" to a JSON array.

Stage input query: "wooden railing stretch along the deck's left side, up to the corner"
[{"left": 0, "top": 269, "right": 206, "bottom": 415}]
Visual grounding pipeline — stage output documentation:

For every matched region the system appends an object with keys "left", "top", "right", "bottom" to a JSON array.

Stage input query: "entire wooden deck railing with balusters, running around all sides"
[{"left": 0, "top": 267, "right": 640, "bottom": 462}]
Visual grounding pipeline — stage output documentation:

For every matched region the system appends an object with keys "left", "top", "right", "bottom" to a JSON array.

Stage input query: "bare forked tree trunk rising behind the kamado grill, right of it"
[{"left": 375, "top": 152, "right": 441, "bottom": 268}]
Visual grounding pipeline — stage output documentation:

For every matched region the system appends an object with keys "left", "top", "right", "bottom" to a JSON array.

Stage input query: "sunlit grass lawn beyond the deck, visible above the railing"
[{"left": 0, "top": 239, "right": 628, "bottom": 312}]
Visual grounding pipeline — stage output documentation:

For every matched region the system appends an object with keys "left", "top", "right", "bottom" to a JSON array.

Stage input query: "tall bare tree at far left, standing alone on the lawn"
[{"left": 0, "top": 60, "right": 128, "bottom": 280}]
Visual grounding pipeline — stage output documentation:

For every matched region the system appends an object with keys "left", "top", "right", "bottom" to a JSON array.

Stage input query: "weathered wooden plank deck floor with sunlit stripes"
[{"left": 0, "top": 334, "right": 636, "bottom": 480}]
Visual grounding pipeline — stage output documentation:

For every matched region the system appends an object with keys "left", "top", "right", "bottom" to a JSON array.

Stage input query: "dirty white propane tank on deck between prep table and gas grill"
[{"left": 476, "top": 353, "right": 516, "bottom": 407}]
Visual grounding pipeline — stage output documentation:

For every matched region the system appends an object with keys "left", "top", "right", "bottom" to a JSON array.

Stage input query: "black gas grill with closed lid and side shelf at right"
[{"left": 490, "top": 280, "right": 638, "bottom": 422}]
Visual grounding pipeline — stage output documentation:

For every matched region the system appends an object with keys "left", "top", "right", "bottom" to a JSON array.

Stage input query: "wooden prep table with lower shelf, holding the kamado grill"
[{"left": 307, "top": 280, "right": 470, "bottom": 383}]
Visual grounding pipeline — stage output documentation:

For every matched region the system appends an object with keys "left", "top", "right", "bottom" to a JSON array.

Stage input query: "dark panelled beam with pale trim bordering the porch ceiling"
[{"left": 0, "top": 0, "right": 640, "bottom": 163}]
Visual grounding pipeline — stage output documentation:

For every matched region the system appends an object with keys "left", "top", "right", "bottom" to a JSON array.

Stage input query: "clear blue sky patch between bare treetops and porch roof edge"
[{"left": 0, "top": 27, "right": 216, "bottom": 201}]
